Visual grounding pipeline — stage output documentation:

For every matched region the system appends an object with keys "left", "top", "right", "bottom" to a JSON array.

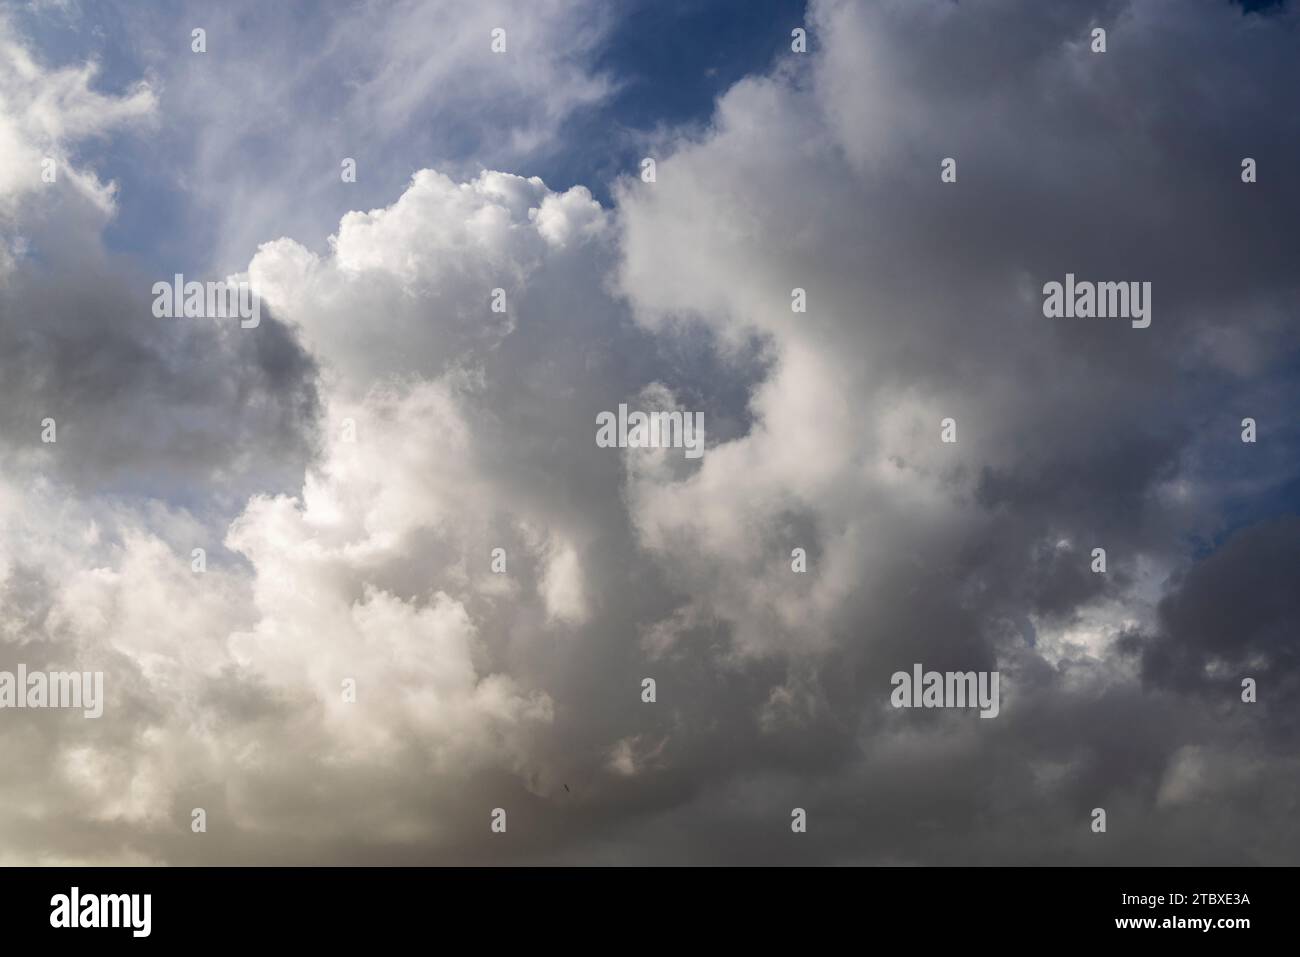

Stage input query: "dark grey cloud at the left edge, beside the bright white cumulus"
[{"left": 0, "top": 261, "right": 317, "bottom": 502}]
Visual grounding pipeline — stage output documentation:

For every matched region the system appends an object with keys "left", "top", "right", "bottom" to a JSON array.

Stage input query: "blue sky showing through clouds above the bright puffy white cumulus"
[{"left": 14, "top": 0, "right": 803, "bottom": 272}]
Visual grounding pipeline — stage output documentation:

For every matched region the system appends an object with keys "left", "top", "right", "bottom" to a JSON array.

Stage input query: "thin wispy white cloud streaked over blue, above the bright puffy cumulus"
[{"left": 113, "top": 0, "right": 614, "bottom": 270}]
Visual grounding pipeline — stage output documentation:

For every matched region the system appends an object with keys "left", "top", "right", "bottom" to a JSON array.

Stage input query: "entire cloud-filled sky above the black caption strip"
[{"left": 0, "top": 0, "right": 1300, "bottom": 865}]
